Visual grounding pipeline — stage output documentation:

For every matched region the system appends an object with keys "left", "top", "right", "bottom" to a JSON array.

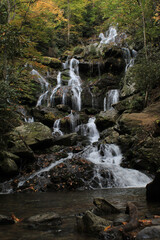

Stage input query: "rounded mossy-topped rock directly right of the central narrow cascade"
[{"left": 95, "top": 109, "right": 117, "bottom": 131}]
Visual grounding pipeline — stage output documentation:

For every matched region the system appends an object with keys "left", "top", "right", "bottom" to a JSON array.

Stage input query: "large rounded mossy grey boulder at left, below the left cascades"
[{"left": 9, "top": 122, "right": 53, "bottom": 152}]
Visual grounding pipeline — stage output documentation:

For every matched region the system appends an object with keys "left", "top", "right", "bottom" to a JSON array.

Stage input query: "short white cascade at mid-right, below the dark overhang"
[{"left": 104, "top": 89, "right": 119, "bottom": 111}]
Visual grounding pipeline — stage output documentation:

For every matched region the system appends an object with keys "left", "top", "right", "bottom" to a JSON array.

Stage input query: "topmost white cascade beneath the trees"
[{"left": 99, "top": 27, "right": 118, "bottom": 44}]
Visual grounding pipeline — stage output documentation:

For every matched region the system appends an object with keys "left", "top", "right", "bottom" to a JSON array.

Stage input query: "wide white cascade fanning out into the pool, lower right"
[{"left": 79, "top": 118, "right": 151, "bottom": 188}]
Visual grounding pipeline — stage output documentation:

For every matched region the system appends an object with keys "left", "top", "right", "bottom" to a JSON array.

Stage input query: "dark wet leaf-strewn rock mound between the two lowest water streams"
[{"left": 48, "top": 158, "right": 94, "bottom": 190}]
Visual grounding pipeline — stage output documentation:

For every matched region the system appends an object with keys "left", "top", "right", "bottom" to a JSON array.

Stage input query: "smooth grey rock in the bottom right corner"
[{"left": 136, "top": 226, "right": 160, "bottom": 240}]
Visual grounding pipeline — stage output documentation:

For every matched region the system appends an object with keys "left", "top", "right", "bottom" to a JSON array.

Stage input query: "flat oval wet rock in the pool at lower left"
[{"left": 26, "top": 212, "right": 62, "bottom": 231}]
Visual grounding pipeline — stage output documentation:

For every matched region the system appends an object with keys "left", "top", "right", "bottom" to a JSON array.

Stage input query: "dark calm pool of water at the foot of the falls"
[{"left": 0, "top": 188, "right": 160, "bottom": 240}]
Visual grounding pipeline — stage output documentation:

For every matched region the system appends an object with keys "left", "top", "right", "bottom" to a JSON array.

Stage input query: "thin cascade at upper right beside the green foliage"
[{"left": 122, "top": 48, "right": 137, "bottom": 72}]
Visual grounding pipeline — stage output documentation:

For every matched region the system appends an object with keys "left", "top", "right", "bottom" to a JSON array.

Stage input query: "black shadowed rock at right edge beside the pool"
[{"left": 146, "top": 170, "right": 160, "bottom": 202}]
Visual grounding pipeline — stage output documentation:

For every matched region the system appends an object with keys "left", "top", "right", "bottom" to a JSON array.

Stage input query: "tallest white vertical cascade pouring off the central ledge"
[{"left": 68, "top": 58, "right": 82, "bottom": 111}]
